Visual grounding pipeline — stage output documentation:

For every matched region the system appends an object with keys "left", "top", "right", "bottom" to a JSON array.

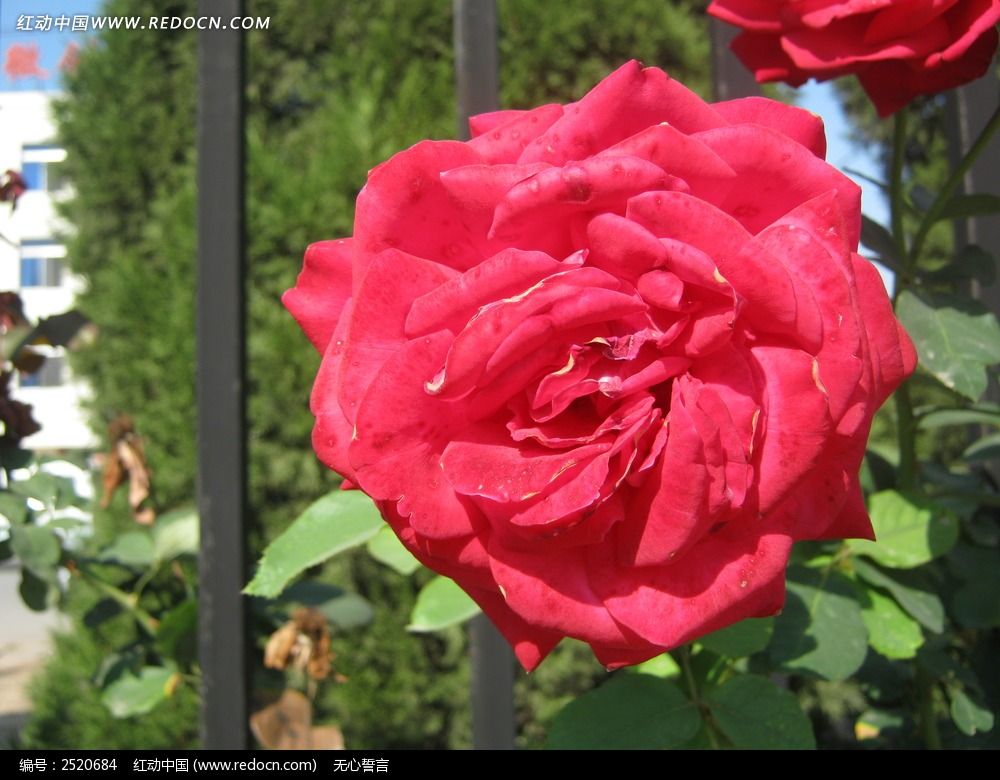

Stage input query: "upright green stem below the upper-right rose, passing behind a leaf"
[{"left": 889, "top": 109, "right": 917, "bottom": 490}]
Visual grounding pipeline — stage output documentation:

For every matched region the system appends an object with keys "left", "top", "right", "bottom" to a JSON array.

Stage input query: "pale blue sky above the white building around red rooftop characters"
[{"left": 0, "top": 0, "right": 102, "bottom": 91}]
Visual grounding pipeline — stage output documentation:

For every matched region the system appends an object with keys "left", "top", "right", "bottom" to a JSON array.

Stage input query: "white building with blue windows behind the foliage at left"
[{"left": 0, "top": 91, "right": 97, "bottom": 450}]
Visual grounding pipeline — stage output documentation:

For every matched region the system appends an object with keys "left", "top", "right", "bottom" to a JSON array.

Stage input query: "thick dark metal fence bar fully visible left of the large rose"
[{"left": 197, "top": 0, "right": 249, "bottom": 749}]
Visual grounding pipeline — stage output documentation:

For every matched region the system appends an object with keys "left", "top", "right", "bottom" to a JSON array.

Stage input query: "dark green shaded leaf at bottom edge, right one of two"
[{"left": 707, "top": 674, "right": 816, "bottom": 750}]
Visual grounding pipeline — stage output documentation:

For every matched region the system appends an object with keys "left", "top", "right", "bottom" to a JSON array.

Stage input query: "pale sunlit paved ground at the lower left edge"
[{"left": 0, "top": 562, "right": 59, "bottom": 746}]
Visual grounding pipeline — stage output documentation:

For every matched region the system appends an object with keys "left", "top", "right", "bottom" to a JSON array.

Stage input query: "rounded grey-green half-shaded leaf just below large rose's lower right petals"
[{"left": 768, "top": 567, "right": 868, "bottom": 680}]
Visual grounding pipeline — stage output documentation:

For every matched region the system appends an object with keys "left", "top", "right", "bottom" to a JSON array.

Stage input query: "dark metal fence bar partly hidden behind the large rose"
[{"left": 453, "top": 0, "right": 514, "bottom": 750}]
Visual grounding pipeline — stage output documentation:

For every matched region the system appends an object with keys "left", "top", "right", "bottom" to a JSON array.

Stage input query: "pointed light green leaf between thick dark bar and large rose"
[{"left": 244, "top": 490, "right": 383, "bottom": 598}]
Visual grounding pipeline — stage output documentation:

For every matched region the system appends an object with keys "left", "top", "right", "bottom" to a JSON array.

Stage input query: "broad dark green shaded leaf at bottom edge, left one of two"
[{"left": 546, "top": 674, "right": 701, "bottom": 750}]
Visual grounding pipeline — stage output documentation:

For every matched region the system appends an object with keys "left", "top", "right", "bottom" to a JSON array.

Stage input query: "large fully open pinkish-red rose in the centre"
[{"left": 284, "top": 62, "right": 915, "bottom": 668}]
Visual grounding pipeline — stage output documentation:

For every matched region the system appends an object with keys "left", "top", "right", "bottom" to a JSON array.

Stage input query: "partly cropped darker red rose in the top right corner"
[{"left": 708, "top": 0, "right": 1000, "bottom": 116}]
